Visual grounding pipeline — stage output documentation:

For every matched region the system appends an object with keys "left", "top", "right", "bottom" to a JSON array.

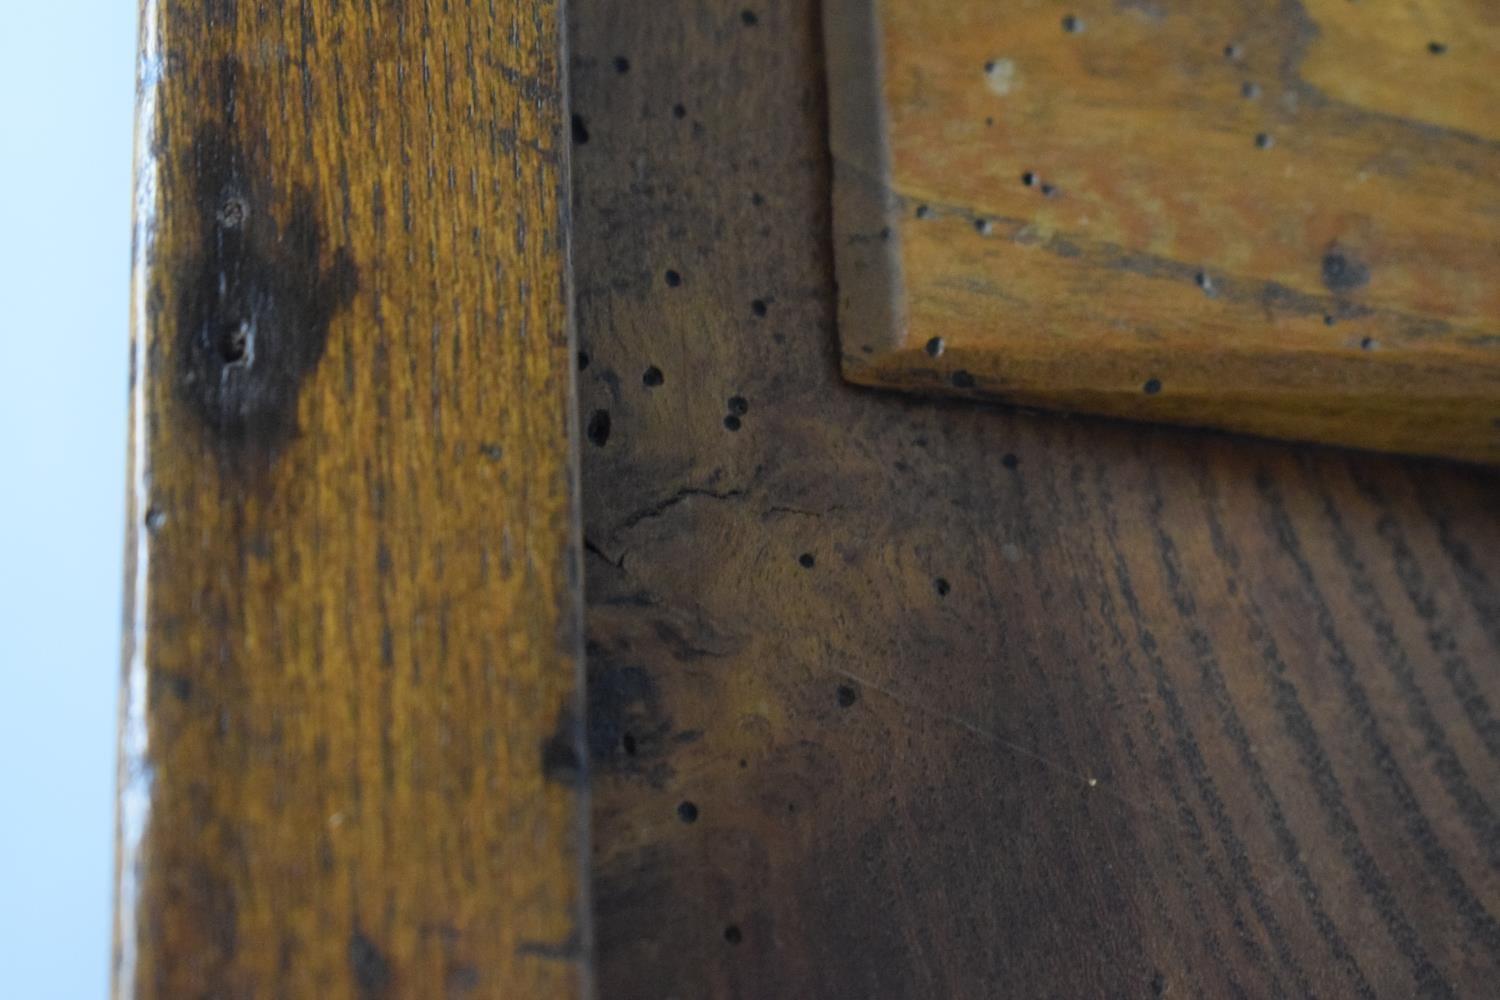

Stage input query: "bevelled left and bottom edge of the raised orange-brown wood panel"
[{"left": 824, "top": 0, "right": 1500, "bottom": 465}]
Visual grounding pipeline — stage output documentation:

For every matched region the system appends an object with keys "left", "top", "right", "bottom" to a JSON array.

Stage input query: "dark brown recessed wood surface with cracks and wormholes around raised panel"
[{"left": 570, "top": 0, "right": 1500, "bottom": 999}]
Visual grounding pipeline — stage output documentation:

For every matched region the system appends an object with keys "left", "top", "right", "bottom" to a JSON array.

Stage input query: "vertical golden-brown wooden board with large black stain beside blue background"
[{"left": 116, "top": 0, "right": 590, "bottom": 1000}]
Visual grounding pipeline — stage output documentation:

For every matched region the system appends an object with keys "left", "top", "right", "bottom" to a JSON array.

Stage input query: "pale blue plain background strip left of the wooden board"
[{"left": 0, "top": 0, "right": 137, "bottom": 1000}]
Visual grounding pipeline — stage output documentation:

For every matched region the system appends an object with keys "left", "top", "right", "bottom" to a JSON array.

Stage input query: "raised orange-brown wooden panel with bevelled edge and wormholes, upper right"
[{"left": 824, "top": 0, "right": 1500, "bottom": 462}]
